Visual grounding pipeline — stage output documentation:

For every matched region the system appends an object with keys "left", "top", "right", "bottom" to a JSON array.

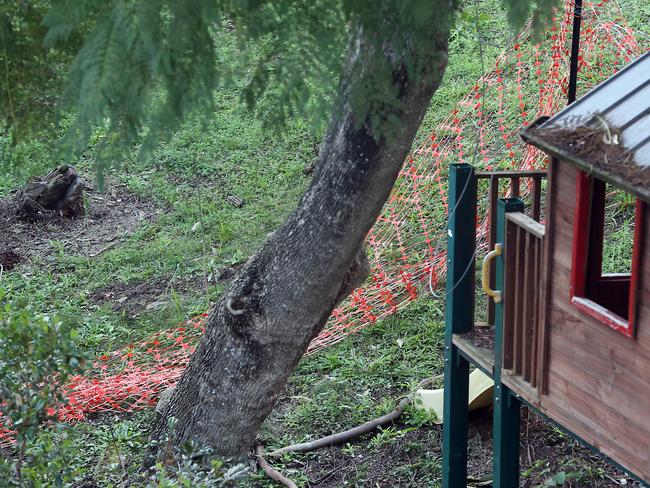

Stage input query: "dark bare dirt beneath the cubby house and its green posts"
[{"left": 274, "top": 408, "right": 641, "bottom": 488}]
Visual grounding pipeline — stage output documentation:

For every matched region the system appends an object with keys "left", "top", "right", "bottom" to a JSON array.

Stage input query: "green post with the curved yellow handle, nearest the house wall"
[{"left": 493, "top": 198, "right": 524, "bottom": 488}]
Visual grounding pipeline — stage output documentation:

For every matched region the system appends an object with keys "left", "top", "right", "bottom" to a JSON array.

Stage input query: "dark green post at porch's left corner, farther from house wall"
[{"left": 442, "top": 164, "right": 476, "bottom": 488}]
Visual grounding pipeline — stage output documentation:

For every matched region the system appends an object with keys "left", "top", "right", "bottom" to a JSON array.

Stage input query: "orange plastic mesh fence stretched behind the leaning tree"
[{"left": 0, "top": 0, "right": 650, "bottom": 445}]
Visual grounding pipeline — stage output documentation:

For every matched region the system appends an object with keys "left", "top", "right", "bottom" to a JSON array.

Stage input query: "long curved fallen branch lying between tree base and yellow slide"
[{"left": 268, "top": 375, "right": 441, "bottom": 457}]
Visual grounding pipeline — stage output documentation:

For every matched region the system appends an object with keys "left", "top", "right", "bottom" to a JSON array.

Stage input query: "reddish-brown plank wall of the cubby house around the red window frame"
[{"left": 536, "top": 162, "right": 650, "bottom": 481}]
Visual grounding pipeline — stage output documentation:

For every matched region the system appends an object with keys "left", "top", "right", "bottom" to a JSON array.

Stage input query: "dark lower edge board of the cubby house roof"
[{"left": 519, "top": 124, "right": 650, "bottom": 202}]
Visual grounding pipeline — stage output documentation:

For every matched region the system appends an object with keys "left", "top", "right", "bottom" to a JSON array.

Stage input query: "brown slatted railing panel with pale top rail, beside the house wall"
[{"left": 503, "top": 212, "right": 546, "bottom": 387}]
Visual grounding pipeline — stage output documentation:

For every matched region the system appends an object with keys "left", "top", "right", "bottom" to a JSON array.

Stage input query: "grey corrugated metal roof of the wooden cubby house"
[{"left": 522, "top": 51, "right": 650, "bottom": 200}]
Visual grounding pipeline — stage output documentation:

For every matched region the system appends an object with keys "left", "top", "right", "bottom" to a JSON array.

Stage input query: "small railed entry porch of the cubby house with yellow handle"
[{"left": 446, "top": 164, "right": 546, "bottom": 397}]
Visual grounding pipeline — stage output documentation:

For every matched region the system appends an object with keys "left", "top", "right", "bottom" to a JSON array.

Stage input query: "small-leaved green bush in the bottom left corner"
[{"left": 0, "top": 290, "right": 81, "bottom": 487}]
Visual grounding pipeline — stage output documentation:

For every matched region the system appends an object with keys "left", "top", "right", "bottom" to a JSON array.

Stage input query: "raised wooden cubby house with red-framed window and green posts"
[{"left": 443, "top": 53, "right": 650, "bottom": 488}]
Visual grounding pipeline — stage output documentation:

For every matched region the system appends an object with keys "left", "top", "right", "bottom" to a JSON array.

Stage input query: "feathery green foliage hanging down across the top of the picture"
[{"left": 40, "top": 0, "right": 555, "bottom": 181}]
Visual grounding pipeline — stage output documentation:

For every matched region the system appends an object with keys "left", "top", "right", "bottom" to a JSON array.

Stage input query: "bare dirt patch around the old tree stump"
[{"left": 0, "top": 185, "right": 161, "bottom": 268}]
